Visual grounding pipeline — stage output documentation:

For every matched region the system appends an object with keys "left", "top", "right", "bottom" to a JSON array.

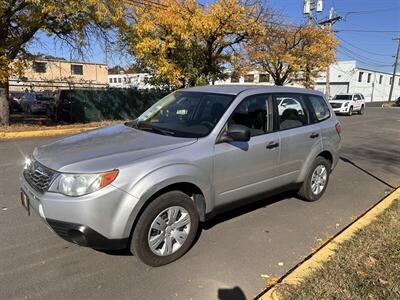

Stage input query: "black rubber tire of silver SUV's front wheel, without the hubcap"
[{"left": 130, "top": 191, "right": 199, "bottom": 267}]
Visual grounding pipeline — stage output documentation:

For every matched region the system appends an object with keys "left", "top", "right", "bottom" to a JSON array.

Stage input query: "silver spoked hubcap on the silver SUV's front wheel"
[{"left": 147, "top": 206, "right": 191, "bottom": 256}]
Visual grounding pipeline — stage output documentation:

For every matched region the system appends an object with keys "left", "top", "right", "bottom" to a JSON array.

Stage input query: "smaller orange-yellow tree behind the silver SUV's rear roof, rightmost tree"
[{"left": 247, "top": 23, "right": 337, "bottom": 88}]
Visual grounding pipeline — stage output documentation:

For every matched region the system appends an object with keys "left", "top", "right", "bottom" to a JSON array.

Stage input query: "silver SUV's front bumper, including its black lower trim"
[{"left": 20, "top": 174, "right": 138, "bottom": 249}]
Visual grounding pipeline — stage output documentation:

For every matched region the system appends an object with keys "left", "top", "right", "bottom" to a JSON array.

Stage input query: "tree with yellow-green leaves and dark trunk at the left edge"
[{"left": 0, "top": 0, "right": 125, "bottom": 124}]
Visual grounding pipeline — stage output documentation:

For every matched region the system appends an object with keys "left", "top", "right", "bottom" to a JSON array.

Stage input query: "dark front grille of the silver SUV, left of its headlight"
[{"left": 24, "top": 160, "right": 54, "bottom": 193}]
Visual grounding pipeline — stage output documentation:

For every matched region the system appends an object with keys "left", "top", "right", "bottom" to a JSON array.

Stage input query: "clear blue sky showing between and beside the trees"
[{"left": 30, "top": 0, "right": 400, "bottom": 72}]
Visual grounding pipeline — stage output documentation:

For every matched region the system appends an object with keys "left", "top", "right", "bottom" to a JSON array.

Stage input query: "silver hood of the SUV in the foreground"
[{"left": 33, "top": 124, "right": 197, "bottom": 173}]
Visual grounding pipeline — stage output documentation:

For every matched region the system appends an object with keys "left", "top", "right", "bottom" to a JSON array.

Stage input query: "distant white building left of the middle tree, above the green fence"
[{"left": 108, "top": 73, "right": 153, "bottom": 89}]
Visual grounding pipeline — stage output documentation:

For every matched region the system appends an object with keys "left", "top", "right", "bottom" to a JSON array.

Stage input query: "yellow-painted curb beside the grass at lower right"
[{"left": 258, "top": 188, "right": 400, "bottom": 300}]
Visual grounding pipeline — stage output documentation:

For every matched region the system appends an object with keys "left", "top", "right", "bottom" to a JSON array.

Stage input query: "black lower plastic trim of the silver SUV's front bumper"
[{"left": 46, "top": 219, "right": 128, "bottom": 250}]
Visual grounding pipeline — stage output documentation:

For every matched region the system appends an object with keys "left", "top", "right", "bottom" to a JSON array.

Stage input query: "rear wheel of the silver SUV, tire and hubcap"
[{"left": 298, "top": 156, "right": 331, "bottom": 202}]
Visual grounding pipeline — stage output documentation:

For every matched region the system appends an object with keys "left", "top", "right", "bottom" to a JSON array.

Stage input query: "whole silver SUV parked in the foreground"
[{"left": 20, "top": 86, "right": 341, "bottom": 266}]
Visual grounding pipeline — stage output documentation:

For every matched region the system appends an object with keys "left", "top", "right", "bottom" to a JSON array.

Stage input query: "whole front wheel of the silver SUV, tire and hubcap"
[{"left": 130, "top": 191, "right": 199, "bottom": 267}]
